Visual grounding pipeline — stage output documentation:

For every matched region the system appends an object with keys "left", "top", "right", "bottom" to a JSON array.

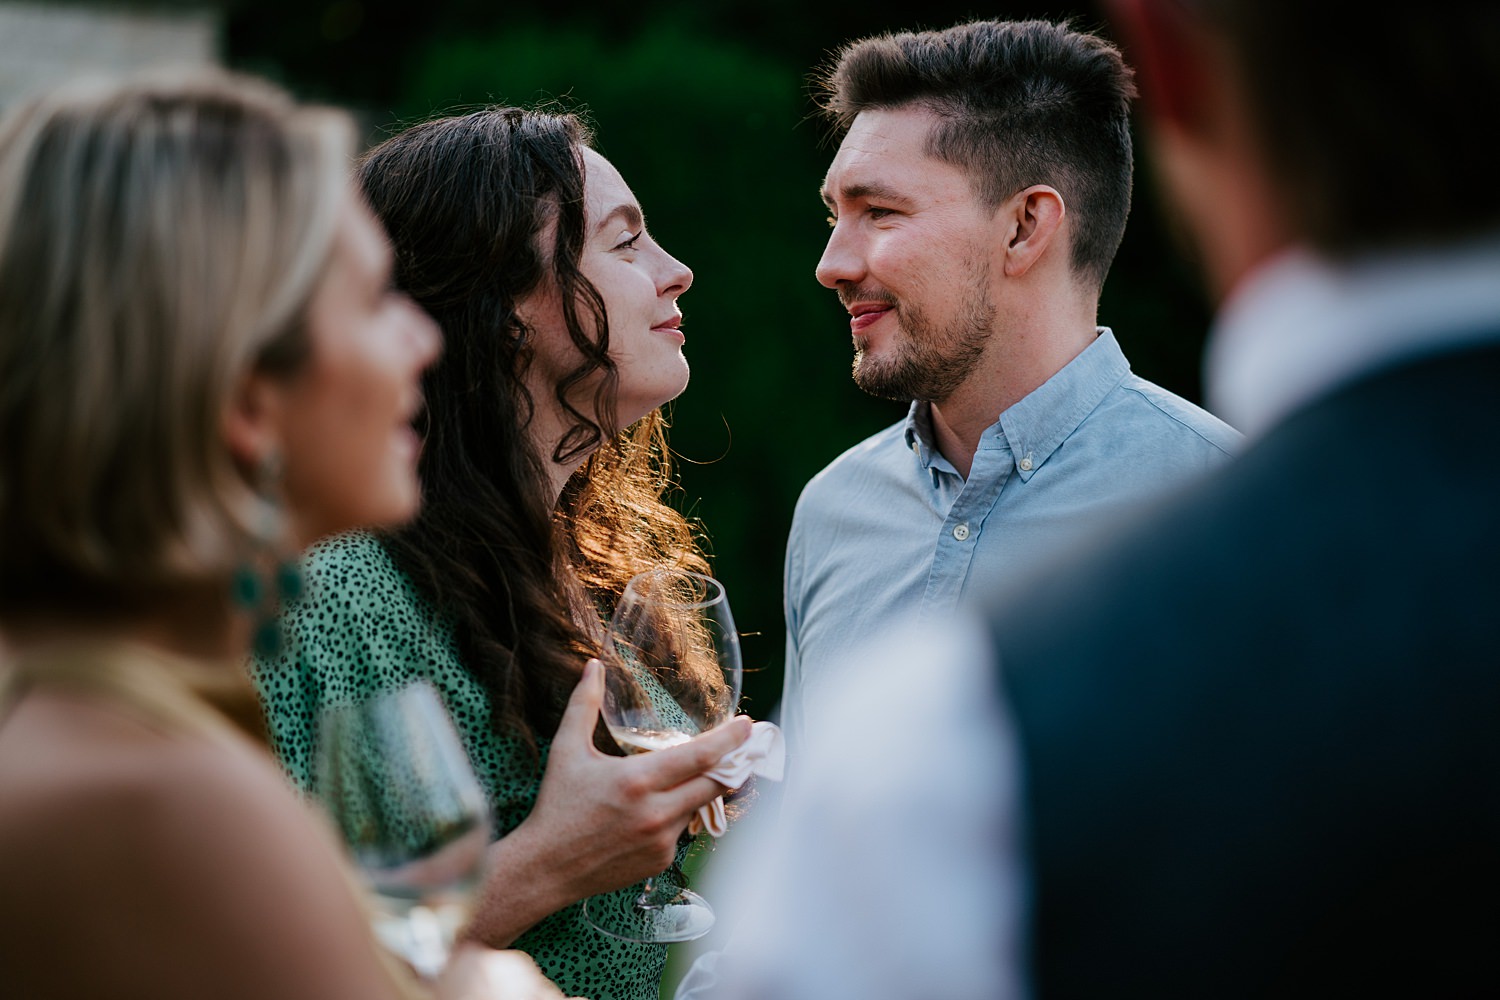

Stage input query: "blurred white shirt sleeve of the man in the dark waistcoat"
[{"left": 680, "top": 621, "right": 1025, "bottom": 1000}]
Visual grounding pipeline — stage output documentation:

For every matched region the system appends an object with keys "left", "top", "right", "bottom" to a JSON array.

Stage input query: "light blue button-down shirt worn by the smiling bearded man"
[{"left": 780, "top": 328, "right": 1239, "bottom": 754}]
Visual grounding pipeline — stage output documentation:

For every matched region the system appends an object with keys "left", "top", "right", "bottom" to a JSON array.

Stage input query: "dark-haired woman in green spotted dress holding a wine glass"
[{"left": 255, "top": 108, "right": 762, "bottom": 1000}]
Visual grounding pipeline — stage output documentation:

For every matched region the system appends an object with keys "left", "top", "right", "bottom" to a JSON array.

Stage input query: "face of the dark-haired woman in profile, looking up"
[{"left": 530, "top": 148, "right": 693, "bottom": 427}]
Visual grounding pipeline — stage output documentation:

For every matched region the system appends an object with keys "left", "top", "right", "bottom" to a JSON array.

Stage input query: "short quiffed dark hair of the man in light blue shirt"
[{"left": 815, "top": 21, "right": 1136, "bottom": 285}]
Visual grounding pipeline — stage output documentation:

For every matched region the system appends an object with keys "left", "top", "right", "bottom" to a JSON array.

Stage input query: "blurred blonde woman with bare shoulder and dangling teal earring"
[{"left": 0, "top": 75, "right": 561, "bottom": 1000}]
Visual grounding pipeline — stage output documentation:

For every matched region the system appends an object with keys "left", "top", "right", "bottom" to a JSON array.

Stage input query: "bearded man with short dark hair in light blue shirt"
[{"left": 782, "top": 21, "right": 1238, "bottom": 754}]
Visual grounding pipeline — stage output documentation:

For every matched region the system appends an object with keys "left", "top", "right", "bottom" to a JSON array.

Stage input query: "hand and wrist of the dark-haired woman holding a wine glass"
[{"left": 465, "top": 660, "right": 750, "bottom": 948}]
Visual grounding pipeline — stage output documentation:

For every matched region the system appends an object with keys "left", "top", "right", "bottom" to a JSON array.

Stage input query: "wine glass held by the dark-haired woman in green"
[{"left": 584, "top": 568, "right": 741, "bottom": 943}]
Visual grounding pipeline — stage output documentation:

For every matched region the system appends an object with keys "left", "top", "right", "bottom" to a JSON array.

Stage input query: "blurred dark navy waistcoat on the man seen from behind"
[{"left": 992, "top": 340, "right": 1500, "bottom": 999}]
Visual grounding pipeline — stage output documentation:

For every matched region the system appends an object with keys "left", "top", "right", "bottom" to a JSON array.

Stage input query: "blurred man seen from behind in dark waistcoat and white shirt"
[{"left": 708, "top": 0, "right": 1500, "bottom": 999}]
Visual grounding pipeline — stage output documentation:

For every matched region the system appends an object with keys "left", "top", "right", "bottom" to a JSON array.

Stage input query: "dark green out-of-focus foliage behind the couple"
[{"left": 224, "top": 0, "right": 1206, "bottom": 717}]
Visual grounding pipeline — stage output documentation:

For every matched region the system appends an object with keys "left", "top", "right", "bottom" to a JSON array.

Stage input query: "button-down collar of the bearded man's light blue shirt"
[{"left": 905, "top": 327, "right": 1130, "bottom": 480}]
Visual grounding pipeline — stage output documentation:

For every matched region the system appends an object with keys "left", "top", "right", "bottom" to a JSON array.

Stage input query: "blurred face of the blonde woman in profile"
[{"left": 282, "top": 196, "right": 441, "bottom": 544}]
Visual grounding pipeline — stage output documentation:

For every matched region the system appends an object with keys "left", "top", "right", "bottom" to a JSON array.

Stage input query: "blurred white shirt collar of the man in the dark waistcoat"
[{"left": 1205, "top": 234, "right": 1500, "bottom": 435}]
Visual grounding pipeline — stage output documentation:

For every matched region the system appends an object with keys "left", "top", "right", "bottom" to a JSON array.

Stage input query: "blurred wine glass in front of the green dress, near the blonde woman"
[{"left": 314, "top": 681, "right": 491, "bottom": 979}]
